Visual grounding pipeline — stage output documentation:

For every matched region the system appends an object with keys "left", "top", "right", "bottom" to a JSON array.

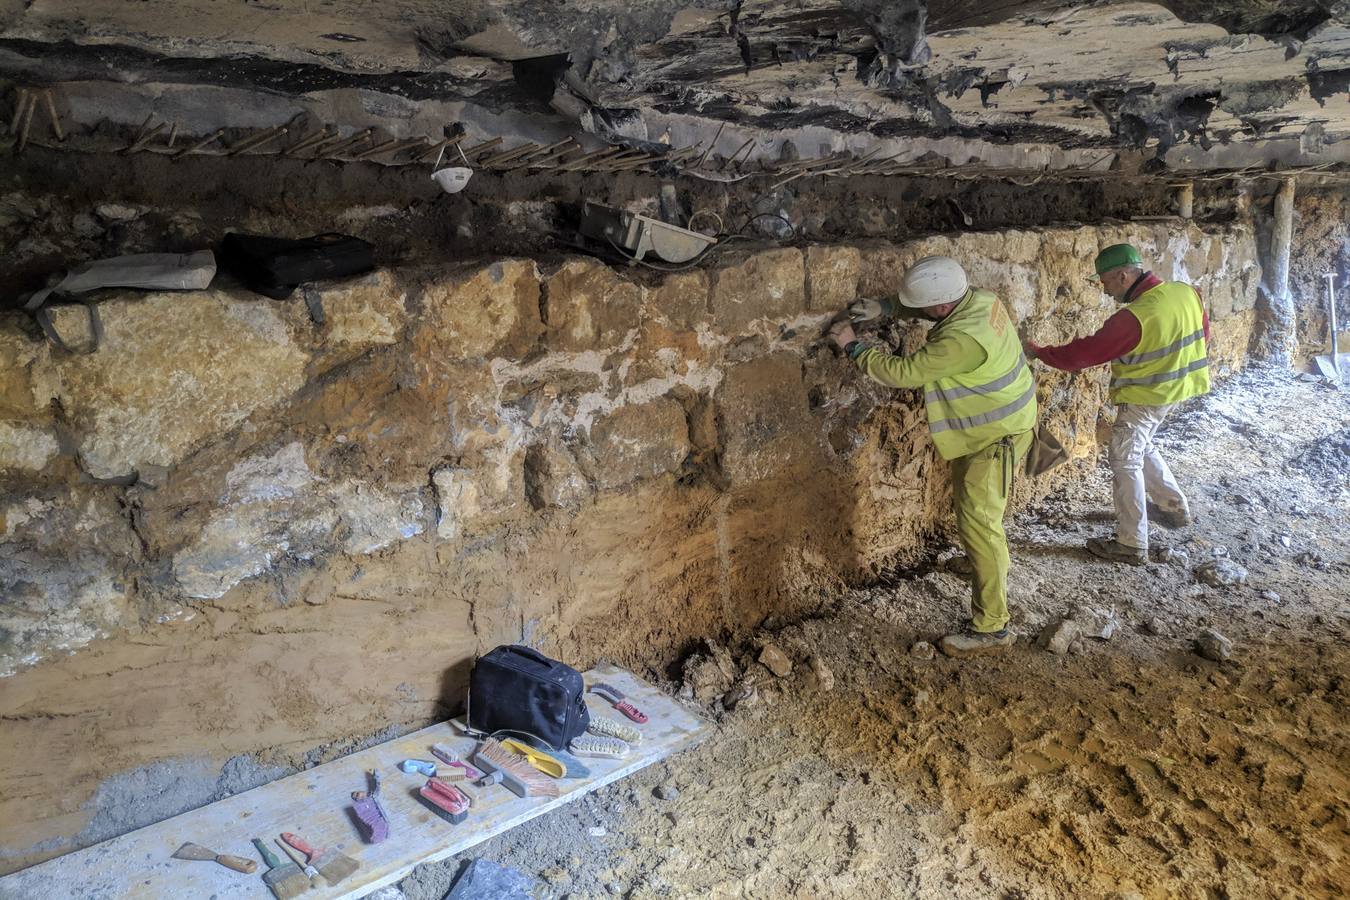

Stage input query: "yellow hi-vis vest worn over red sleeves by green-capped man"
[{"left": 1111, "top": 281, "right": 1210, "bottom": 406}]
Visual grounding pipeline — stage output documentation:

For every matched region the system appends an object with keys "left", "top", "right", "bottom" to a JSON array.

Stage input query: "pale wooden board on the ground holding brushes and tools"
[{"left": 0, "top": 665, "right": 707, "bottom": 900}]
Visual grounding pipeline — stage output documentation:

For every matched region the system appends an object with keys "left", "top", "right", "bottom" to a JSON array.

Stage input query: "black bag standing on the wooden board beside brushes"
[{"left": 464, "top": 644, "right": 590, "bottom": 750}]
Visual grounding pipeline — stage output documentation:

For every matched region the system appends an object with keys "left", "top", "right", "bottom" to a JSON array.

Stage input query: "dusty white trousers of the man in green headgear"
[{"left": 1107, "top": 403, "right": 1188, "bottom": 551}]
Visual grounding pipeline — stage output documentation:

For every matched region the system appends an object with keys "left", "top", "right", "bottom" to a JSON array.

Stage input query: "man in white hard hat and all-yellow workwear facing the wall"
[{"left": 830, "top": 256, "right": 1035, "bottom": 656}]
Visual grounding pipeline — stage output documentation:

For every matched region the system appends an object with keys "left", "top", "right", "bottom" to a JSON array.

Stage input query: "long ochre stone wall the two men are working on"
[{"left": 0, "top": 223, "right": 1260, "bottom": 870}]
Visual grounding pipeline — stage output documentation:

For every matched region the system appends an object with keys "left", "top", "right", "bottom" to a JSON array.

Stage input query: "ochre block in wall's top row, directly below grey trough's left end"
[{"left": 544, "top": 259, "right": 643, "bottom": 352}]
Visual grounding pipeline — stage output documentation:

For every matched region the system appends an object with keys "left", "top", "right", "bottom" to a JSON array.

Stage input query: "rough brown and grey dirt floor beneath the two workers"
[{"left": 383, "top": 368, "right": 1350, "bottom": 900}]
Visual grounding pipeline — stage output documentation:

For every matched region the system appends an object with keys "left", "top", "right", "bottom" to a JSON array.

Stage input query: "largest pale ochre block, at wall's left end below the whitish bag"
[{"left": 34, "top": 290, "right": 308, "bottom": 478}]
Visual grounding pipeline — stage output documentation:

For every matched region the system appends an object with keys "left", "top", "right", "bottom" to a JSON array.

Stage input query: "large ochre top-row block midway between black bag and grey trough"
[{"left": 414, "top": 259, "right": 544, "bottom": 359}]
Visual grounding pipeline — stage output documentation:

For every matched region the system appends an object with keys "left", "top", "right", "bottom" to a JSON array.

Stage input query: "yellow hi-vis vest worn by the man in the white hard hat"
[{"left": 923, "top": 290, "right": 1035, "bottom": 459}]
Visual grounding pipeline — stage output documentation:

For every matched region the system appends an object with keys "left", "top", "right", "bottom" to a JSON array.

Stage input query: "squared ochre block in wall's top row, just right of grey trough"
[{"left": 711, "top": 247, "right": 806, "bottom": 335}]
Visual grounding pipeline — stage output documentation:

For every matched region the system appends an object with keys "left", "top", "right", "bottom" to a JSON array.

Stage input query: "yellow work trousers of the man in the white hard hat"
[{"left": 952, "top": 432, "right": 1031, "bottom": 631}]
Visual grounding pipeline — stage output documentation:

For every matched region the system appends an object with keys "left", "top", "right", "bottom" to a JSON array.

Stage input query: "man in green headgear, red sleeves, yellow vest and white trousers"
[{"left": 1026, "top": 244, "right": 1210, "bottom": 565}]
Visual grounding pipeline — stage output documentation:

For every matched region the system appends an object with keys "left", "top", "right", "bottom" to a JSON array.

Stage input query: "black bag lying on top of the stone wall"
[{"left": 219, "top": 232, "right": 375, "bottom": 300}]
